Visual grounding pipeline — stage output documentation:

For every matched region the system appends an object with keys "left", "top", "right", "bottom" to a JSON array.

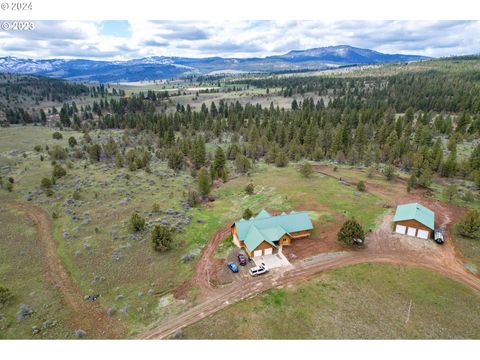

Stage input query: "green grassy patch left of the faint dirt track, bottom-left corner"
[{"left": 0, "top": 206, "right": 75, "bottom": 339}]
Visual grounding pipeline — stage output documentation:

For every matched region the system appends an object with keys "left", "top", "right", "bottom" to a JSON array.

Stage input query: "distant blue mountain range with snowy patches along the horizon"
[{"left": 0, "top": 45, "right": 427, "bottom": 83}]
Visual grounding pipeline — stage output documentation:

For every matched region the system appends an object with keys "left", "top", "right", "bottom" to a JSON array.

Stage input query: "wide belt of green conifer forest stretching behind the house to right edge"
[{"left": 0, "top": 58, "right": 480, "bottom": 186}]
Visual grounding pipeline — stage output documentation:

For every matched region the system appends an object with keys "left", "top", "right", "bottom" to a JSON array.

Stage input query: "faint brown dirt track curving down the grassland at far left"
[{"left": 7, "top": 202, "right": 126, "bottom": 339}]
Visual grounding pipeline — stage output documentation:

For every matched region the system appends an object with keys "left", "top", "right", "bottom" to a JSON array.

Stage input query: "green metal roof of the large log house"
[{"left": 235, "top": 210, "right": 313, "bottom": 251}]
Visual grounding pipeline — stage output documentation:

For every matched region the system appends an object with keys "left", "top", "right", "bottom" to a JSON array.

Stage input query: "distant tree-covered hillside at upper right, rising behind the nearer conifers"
[{"left": 233, "top": 56, "right": 480, "bottom": 114}]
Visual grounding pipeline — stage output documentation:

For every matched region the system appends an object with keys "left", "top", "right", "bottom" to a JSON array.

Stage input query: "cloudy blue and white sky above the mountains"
[{"left": 0, "top": 21, "right": 480, "bottom": 60}]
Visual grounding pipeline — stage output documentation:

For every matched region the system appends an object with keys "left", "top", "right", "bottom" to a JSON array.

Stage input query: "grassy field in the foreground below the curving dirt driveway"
[{"left": 183, "top": 264, "right": 480, "bottom": 339}]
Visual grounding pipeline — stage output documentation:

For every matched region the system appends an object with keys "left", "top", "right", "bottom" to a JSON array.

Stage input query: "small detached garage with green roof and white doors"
[{"left": 393, "top": 203, "right": 435, "bottom": 239}]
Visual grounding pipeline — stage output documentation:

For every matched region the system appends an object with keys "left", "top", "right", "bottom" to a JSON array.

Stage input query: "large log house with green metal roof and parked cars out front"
[{"left": 232, "top": 210, "right": 313, "bottom": 257}]
